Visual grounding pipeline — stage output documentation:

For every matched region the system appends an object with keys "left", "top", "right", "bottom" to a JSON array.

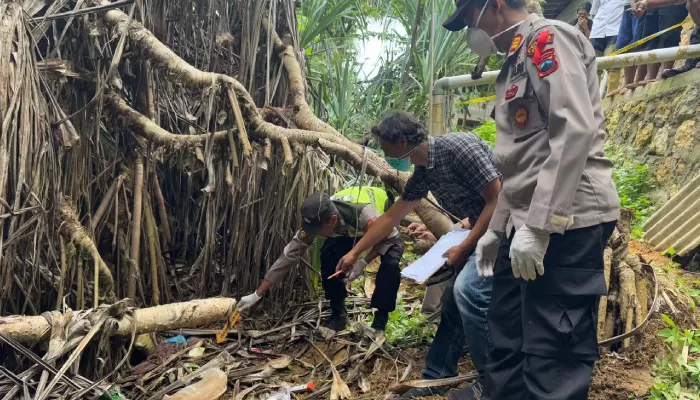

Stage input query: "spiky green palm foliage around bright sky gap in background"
[{"left": 297, "top": 0, "right": 486, "bottom": 140}]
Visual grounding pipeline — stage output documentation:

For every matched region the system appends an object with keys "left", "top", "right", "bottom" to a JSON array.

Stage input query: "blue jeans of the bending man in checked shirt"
[{"left": 423, "top": 254, "right": 493, "bottom": 379}]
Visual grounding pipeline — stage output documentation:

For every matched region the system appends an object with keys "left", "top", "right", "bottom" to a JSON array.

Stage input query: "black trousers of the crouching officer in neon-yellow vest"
[{"left": 321, "top": 236, "right": 404, "bottom": 312}]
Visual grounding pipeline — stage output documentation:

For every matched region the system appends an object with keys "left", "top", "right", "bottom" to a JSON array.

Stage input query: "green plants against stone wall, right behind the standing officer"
[{"left": 606, "top": 145, "right": 658, "bottom": 239}]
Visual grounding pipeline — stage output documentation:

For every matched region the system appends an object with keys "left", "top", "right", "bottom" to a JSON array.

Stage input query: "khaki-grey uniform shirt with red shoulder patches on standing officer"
[{"left": 489, "top": 14, "right": 620, "bottom": 233}]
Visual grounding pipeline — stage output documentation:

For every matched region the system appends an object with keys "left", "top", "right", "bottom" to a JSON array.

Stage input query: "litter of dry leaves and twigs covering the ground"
[{"left": 0, "top": 297, "right": 413, "bottom": 400}]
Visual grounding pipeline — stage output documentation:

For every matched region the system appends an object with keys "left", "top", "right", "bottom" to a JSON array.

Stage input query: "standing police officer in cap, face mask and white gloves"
[{"left": 443, "top": 0, "right": 620, "bottom": 400}]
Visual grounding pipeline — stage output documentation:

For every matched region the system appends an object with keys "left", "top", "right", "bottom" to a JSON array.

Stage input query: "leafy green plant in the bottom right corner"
[{"left": 649, "top": 314, "right": 700, "bottom": 400}]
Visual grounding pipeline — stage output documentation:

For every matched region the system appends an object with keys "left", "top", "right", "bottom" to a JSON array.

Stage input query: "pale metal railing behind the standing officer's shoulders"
[{"left": 430, "top": 44, "right": 700, "bottom": 135}]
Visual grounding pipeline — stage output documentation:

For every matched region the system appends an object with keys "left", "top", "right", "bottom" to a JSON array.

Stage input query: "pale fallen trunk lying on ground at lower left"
[{"left": 0, "top": 297, "right": 236, "bottom": 343}]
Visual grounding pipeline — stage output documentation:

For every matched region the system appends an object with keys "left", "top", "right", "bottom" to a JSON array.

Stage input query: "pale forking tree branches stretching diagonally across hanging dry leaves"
[{"left": 99, "top": 0, "right": 451, "bottom": 244}]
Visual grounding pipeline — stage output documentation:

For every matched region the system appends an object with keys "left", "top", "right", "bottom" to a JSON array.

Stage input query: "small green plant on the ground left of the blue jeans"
[{"left": 368, "top": 294, "right": 435, "bottom": 346}]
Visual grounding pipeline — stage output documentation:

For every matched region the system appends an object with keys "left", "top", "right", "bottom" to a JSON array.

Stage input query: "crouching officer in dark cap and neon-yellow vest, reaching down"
[{"left": 238, "top": 187, "right": 404, "bottom": 331}]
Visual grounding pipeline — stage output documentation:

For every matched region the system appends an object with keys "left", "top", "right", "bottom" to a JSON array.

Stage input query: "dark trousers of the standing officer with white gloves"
[{"left": 482, "top": 222, "right": 615, "bottom": 400}]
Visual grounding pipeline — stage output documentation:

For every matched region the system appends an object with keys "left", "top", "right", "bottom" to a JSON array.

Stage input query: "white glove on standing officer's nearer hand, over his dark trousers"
[{"left": 510, "top": 225, "right": 549, "bottom": 281}]
